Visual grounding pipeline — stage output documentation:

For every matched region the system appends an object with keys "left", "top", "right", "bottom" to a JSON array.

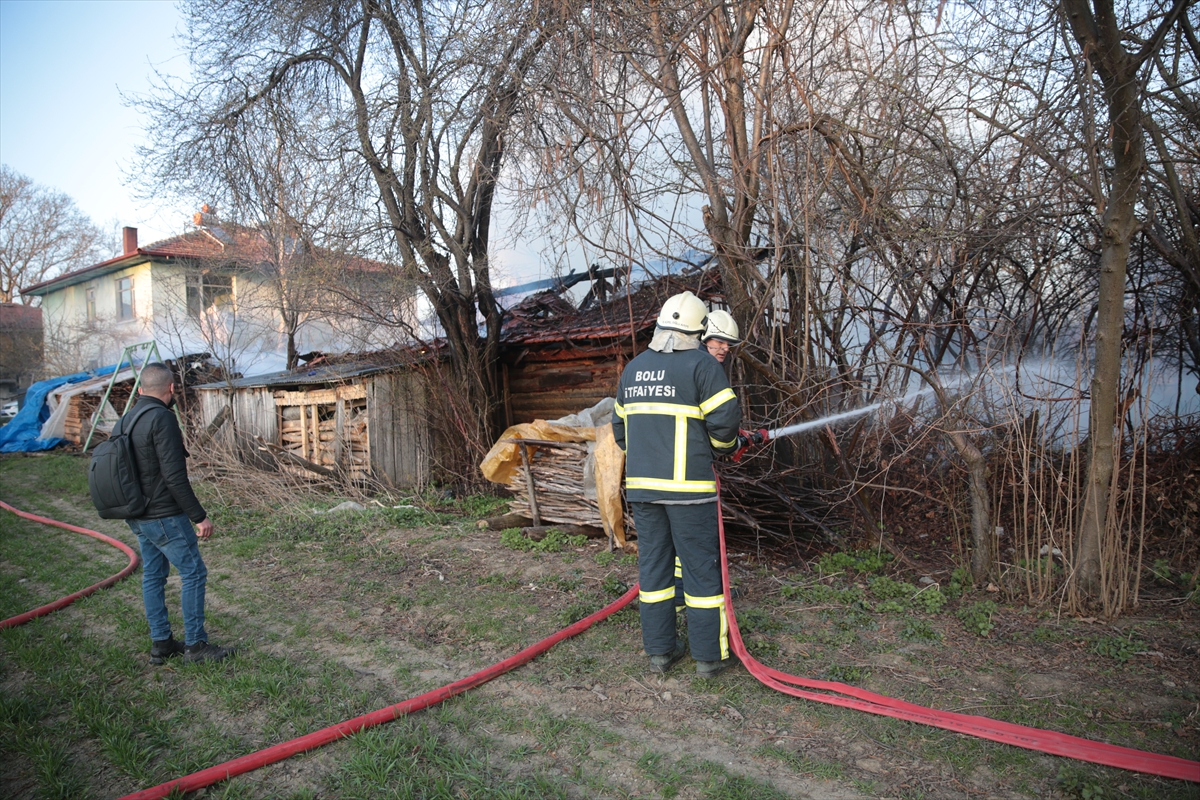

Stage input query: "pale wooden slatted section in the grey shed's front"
[{"left": 275, "top": 384, "right": 371, "bottom": 480}]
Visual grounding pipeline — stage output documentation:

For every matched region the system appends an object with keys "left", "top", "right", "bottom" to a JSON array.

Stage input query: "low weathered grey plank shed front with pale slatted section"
[{"left": 194, "top": 357, "right": 436, "bottom": 487}]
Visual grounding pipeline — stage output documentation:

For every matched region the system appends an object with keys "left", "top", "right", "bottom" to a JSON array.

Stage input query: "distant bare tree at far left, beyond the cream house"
[{"left": 0, "top": 164, "right": 102, "bottom": 305}]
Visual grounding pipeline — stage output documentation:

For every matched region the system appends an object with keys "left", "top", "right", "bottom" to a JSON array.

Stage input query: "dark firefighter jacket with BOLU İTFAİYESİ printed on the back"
[{"left": 612, "top": 349, "right": 742, "bottom": 503}]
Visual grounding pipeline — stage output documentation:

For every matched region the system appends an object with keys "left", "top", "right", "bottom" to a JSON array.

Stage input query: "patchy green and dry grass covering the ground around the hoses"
[{"left": 0, "top": 455, "right": 1195, "bottom": 800}]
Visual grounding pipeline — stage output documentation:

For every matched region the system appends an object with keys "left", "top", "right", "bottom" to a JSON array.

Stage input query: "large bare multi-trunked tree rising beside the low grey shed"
[{"left": 141, "top": 0, "right": 566, "bottom": 455}]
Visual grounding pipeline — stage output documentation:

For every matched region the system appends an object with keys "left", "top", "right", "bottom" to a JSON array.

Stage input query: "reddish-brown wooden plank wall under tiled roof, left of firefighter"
[{"left": 505, "top": 353, "right": 624, "bottom": 425}]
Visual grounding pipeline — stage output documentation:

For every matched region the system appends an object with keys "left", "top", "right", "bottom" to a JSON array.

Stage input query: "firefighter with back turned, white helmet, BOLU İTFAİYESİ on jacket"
[{"left": 612, "top": 291, "right": 742, "bottom": 676}]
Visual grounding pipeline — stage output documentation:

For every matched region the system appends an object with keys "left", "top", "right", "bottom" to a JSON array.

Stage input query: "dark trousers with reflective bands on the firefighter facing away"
[{"left": 630, "top": 503, "right": 730, "bottom": 661}]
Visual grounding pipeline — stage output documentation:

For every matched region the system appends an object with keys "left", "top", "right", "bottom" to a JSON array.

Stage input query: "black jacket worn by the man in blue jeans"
[{"left": 121, "top": 395, "right": 208, "bottom": 523}]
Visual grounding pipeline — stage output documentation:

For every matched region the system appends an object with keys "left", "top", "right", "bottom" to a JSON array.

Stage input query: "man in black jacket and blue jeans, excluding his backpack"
[{"left": 114, "top": 362, "right": 232, "bottom": 664}]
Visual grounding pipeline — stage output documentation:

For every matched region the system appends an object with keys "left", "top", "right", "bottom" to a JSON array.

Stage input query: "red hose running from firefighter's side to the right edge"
[{"left": 716, "top": 483, "right": 1200, "bottom": 782}]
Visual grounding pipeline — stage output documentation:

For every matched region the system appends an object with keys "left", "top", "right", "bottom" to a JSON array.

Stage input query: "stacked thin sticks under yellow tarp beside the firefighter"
[{"left": 508, "top": 441, "right": 634, "bottom": 535}]
